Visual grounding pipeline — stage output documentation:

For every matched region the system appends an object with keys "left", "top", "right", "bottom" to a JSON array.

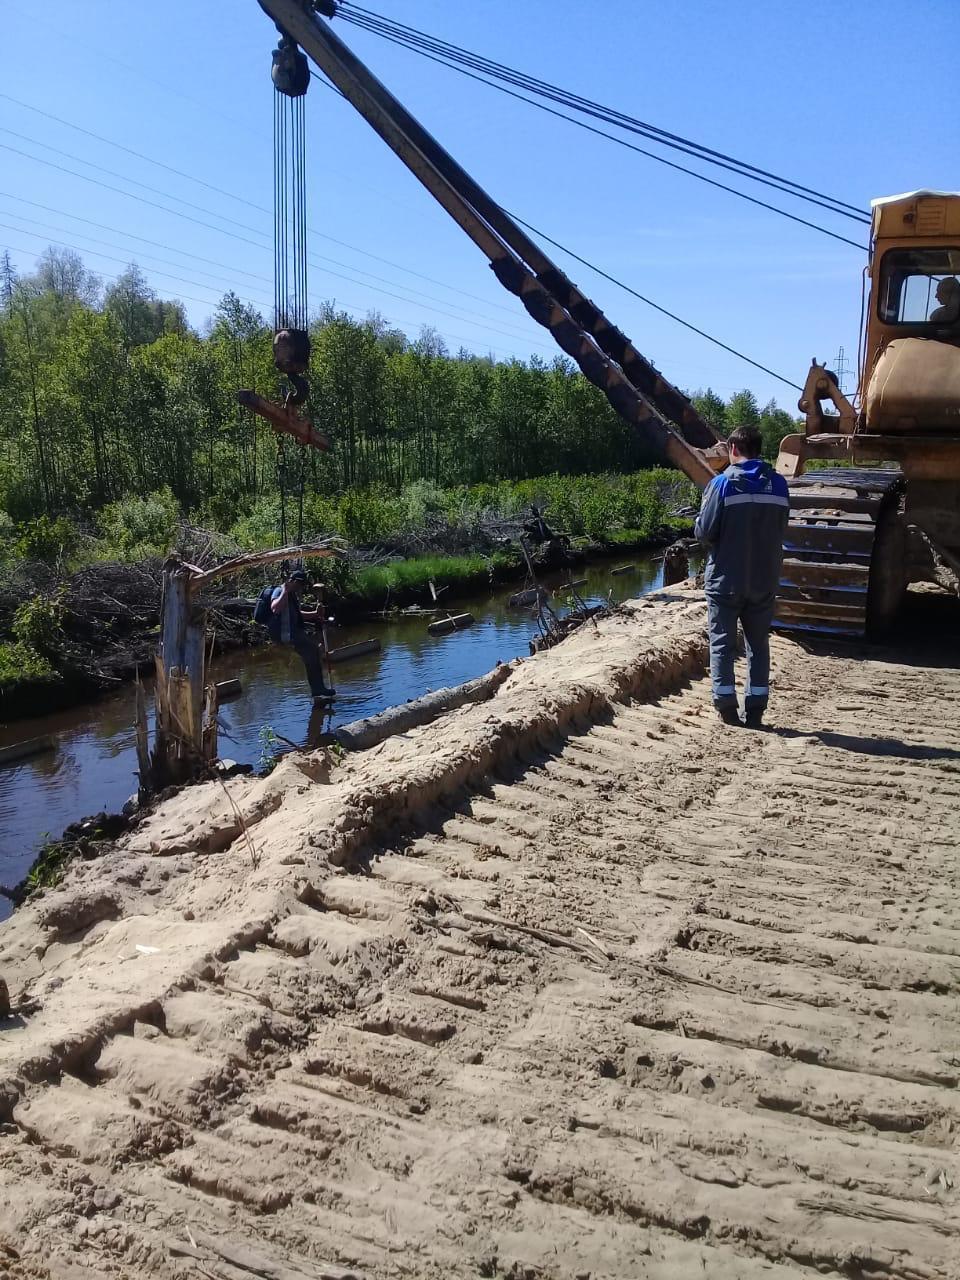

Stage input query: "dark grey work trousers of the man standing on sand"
[{"left": 707, "top": 591, "right": 777, "bottom": 712}]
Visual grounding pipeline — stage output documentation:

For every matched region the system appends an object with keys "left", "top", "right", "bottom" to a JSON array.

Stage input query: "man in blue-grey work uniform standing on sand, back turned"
[{"left": 694, "top": 426, "right": 790, "bottom": 728}]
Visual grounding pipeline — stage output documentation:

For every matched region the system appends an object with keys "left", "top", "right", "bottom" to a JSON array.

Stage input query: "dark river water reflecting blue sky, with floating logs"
[{"left": 0, "top": 554, "right": 662, "bottom": 919}]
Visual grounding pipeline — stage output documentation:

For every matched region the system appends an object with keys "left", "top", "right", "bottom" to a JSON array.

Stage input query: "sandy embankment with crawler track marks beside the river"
[{"left": 0, "top": 589, "right": 960, "bottom": 1280}]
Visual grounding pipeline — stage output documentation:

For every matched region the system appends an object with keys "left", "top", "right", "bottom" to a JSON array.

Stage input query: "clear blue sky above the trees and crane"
[{"left": 0, "top": 0, "right": 960, "bottom": 408}]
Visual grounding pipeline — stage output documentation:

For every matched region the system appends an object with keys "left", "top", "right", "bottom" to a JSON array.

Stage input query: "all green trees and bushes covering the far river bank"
[{"left": 0, "top": 247, "right": 795, "bottom": 708}]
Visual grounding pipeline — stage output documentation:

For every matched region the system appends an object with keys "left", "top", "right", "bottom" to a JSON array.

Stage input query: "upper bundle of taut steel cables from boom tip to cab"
[{"left": 340, "top": 0, "right": 869, "bottom": 223}]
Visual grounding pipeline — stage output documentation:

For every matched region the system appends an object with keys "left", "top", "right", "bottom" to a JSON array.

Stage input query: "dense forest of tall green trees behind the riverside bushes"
[{"left": 0, "top": 247, "right": 794, "bottom": 542}]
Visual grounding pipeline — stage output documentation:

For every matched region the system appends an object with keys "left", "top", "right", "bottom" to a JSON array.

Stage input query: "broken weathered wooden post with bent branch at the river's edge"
[{"left": 137, "top": 538, "right": 342, "bottom": 795}]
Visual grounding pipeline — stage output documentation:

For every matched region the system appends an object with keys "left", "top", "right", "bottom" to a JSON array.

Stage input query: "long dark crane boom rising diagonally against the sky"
[{"left": 259, "top": 0, "right": 726, "bottom": 488}]
